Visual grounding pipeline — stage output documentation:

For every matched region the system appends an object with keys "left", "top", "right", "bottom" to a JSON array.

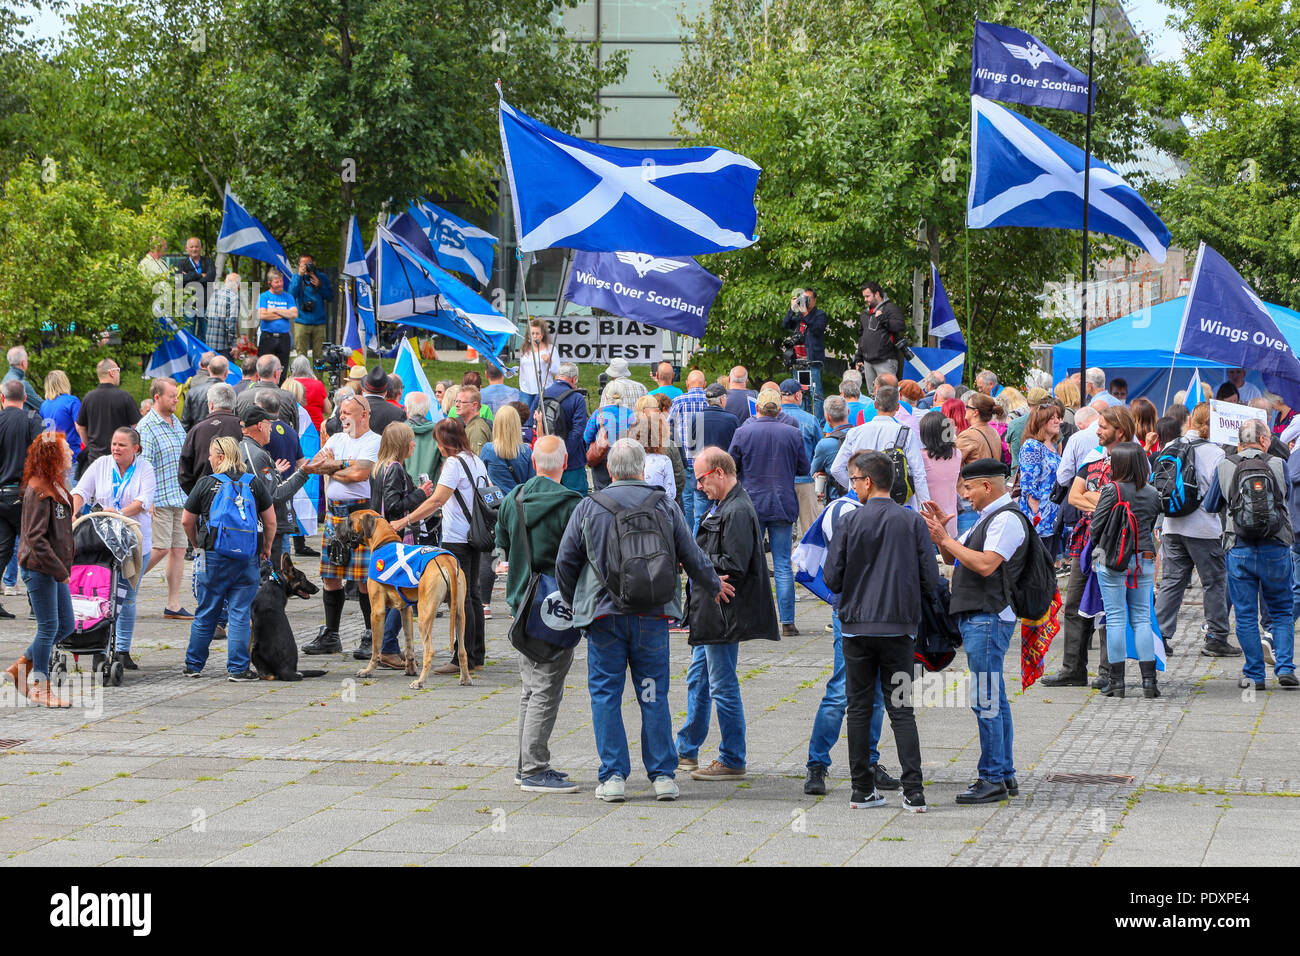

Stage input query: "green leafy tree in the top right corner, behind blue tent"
[{"left": 1139, "top": 0, "right": 1300, "bottom": 308}]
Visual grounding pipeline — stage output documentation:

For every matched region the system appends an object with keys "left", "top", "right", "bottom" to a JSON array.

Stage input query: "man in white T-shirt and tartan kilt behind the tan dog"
[{"left": 303, "top": 395, "right": 380, "bottom": 656}]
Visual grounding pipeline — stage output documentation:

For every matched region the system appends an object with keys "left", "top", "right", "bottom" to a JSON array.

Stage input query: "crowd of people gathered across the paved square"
[{"left": 0, "top": 317, "right": 1300, "bottom": 812}]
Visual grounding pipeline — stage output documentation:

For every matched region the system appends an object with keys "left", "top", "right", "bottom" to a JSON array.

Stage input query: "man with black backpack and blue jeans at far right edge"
[{"left": 1203, "top": 419, "right": 1300, "bottom": 691}]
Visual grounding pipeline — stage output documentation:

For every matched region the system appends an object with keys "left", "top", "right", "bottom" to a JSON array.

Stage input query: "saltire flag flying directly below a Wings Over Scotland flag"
[{"left": 966, "top": 96, "right": 1171, "bottom": 263}]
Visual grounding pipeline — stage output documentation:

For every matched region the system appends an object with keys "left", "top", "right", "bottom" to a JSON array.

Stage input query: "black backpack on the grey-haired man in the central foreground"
[{"left": 592, "top": 489, "right": 677, "bottom": 614}]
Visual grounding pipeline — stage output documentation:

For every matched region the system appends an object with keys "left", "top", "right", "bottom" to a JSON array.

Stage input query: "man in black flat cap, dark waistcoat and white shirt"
[{"left": 924, "top": 458, "right": 1031, "bottom": 804}]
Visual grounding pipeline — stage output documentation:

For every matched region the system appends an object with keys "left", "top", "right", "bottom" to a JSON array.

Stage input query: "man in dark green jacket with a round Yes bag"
[{"left": 497, "top": 434, "right": 582, "bottom": 793}]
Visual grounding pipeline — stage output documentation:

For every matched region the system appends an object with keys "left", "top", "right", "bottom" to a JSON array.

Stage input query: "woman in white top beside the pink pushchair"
[{"left": 73, "top": 427, "right": 157, "bottom": 671}]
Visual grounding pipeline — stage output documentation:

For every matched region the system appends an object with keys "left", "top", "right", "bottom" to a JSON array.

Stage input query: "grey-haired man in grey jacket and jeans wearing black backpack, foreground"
[{"left": 555, "top": 436, "right": 733, "bottom": 803}]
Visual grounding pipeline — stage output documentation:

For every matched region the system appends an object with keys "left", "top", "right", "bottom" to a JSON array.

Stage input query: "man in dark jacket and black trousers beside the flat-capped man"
[{"left": 822, "top": 451, "right": 939, "bottom": 813}]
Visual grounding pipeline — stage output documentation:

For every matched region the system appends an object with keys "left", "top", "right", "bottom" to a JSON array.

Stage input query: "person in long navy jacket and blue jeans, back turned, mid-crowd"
[{"left": 728, "top": 392, "right": 811, "bottom": 637}]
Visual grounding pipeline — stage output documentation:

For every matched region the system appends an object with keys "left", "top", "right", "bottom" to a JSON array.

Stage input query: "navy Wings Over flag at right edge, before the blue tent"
[{"left": 1174, "top": 242, "right": 1300, "bottom": 408}]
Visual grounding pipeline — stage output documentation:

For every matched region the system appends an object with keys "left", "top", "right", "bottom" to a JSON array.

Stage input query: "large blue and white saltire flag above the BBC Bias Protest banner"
[{"left": 499, "top": 100, "right": 761, "bottom": 256}]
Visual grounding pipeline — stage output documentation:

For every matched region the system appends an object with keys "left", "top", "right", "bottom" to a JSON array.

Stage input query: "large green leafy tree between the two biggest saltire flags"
[{"left": 671, "top": 0, "right": 1159, "bottom": 381}]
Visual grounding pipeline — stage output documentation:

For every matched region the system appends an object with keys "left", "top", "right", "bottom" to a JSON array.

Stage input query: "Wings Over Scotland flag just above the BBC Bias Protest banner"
[{"left": 564, "top": 252, "right": 723, "bottom": 338}]
